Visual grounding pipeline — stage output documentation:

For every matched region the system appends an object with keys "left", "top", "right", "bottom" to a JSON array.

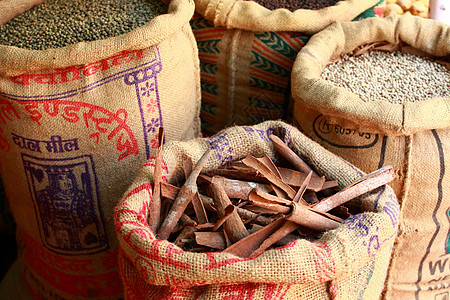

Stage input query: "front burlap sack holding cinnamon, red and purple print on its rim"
[{"left": 114, "top": 121, "right": 399, "bottom": 300}]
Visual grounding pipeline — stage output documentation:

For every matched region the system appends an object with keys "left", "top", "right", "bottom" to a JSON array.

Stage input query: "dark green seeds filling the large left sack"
[{"left": 0, "top": 0, "right": 167, "bottom": 50}]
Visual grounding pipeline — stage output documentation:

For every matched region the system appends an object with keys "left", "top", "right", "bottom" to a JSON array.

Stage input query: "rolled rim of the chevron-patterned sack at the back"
[{"left": 194, "top": 0, "right": 380, "bottom": 34}]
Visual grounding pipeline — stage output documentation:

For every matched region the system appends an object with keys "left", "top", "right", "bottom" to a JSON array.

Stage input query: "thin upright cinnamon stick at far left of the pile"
[{"left": 147, "top": 127, "right": 164, "bottom": 232}]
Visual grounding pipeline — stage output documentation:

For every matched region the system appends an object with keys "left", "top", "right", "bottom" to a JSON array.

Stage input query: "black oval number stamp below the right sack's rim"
[{"left": 313, "top": 114, "right": 379, "bottom": 149}]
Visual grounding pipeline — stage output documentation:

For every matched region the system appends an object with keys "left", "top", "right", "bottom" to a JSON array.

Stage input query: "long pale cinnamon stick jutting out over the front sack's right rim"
[{"left": 313, "top": 166, "right": 395, "bottom": 212}]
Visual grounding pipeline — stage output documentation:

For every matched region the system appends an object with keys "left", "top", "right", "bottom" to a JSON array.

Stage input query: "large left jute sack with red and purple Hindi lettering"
[{"left": 0, "top": 0, "right": 200, "bottom": 299}]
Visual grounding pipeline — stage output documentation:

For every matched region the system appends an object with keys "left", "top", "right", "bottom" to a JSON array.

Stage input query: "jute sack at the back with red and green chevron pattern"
[{"left": 191, "top": 0, "right": 385, "bottom": 134}]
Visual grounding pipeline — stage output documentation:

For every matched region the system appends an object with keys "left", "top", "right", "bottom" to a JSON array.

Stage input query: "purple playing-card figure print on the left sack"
[{"left": 22, "top": 154, "right": 108, "bottom": 255}]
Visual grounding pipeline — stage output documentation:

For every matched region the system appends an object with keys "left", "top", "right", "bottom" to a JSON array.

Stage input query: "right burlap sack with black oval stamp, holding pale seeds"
[{"left": 292, "top": 16, "right": 450, "bottom": 299}]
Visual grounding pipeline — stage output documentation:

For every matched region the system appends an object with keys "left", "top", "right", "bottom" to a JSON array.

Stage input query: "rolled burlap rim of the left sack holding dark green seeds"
[{"left": 0, "top": 0, "right": 194, "bottom": 76}]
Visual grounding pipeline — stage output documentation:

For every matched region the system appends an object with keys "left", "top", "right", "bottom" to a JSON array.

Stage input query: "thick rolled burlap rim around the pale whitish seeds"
[{"left": 291, "top": 15, "right": 450, "bottom": 135}]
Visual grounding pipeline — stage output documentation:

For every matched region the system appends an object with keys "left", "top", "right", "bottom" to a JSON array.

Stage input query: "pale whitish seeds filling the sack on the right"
[{"left": 321, "top": 51, "right": 450, "bottom": 103}]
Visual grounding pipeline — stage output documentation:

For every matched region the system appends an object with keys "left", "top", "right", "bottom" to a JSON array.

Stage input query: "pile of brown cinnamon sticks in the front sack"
[{"left": 148, "top": 129, "right": 394, "bottom": 258}]
